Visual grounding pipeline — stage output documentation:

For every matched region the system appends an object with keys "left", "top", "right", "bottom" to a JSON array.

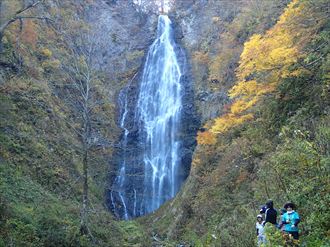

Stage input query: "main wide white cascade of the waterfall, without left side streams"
[{"left": 136, "top": 15, "right": 182, "bottom": 213}]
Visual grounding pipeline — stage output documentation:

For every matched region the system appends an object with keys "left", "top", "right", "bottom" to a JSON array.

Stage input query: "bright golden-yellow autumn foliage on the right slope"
[{"left": 210, "top": 0, "right": 321, "bottom": 134}]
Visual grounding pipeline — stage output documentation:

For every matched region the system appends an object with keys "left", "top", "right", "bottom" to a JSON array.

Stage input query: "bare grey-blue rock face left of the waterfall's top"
[{"left": 85, "top": 1, "right": 157, "bottom": 102}]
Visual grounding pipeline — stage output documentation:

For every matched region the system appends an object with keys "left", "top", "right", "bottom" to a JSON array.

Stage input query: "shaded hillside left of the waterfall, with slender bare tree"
[{"left": 0, "top": 0, "right": 154, "bottom": 246}]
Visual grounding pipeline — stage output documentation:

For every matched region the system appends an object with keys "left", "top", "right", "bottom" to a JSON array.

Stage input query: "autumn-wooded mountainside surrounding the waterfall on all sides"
[{"left": 0, "top": 0, "right": 330, "bottom": 247}]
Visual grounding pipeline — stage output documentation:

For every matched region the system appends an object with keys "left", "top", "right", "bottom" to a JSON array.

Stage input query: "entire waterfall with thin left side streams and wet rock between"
[{"left": 108, "top": 15, "right": 196, "bottom": 220}]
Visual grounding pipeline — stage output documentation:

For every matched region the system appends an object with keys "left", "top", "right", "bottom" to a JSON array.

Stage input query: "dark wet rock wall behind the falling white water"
[{"left": 107, "top": 12, "right": 199, "bottom": 219}]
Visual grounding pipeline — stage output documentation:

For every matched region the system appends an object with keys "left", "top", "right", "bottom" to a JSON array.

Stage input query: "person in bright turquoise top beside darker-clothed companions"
[{"left": 281, "top": 202, "right": 300, "bottom": 240}]
